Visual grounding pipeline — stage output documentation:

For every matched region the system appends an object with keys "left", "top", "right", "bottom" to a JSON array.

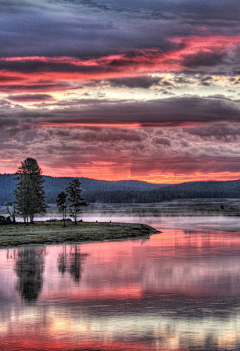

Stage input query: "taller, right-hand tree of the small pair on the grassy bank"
[{"left": 66, "top": 178, "right": 88, "bottom": 224}]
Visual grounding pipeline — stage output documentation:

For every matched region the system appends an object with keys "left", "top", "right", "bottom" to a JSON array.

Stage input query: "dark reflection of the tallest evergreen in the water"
[{"left": 16, "top": 248, "right": 45, "bottom": 302}]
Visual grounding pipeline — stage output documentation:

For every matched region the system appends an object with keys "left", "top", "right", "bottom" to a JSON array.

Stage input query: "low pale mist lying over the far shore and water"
[{"left": 0, "top": 199, "right": 240, "bottom": 231}]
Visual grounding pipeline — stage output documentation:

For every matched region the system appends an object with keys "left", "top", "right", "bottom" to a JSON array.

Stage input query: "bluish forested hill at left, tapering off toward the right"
[{"left": 0, "top": 174, "right": 161, "bottom": 206}]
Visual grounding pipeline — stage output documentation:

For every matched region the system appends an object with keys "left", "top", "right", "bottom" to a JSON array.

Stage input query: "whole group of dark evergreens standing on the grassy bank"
[{"left": 7, "top": 158, "right": 87, "bottom": 226}]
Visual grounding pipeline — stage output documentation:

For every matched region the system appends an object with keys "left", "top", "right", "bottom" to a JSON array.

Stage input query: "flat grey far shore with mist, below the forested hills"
[{"left": 0, "top": 198, "right": 240, "bottom": 222}]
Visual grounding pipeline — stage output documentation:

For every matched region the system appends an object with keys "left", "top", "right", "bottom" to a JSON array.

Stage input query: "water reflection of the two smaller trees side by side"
[{"left": 58, "top": 245, "right": 88, "bottom": 283}]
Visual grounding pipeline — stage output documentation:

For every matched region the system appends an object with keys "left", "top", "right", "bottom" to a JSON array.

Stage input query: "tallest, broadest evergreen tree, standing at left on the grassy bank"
[{"left": 13, "top": 158, "right": 48, "bottom": 223}]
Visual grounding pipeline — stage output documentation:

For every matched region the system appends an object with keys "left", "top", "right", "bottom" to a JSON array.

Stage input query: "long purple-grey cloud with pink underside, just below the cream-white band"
[{"left": 15, "top": 96, "right": 240, "bottom": 126}]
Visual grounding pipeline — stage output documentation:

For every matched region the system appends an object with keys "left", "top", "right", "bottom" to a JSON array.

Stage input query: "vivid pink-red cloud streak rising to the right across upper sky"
[{"left": 0, "top": 36, "right": 240, "bottom": 94}]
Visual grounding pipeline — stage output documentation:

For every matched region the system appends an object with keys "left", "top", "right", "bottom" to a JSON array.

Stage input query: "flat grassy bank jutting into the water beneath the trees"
[{"left": 0, "top": 222, "right": 157, "bottom": 247}]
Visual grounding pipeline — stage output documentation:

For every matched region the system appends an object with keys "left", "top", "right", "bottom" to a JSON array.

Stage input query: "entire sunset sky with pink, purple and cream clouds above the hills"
[{"left": 0, "top": 0, "right": 240, "bottom": 184}]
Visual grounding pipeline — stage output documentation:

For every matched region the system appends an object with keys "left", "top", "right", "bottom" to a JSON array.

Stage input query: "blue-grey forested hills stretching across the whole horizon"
[{"left": 0, "top": 174, "right": 240, "bottom": 206}]
